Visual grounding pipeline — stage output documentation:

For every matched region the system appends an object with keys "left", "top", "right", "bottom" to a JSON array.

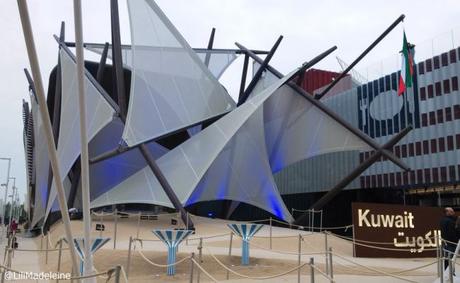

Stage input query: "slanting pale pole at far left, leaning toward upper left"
[{"left": 17, "top": 0, "right": 78, "bottom": 276}]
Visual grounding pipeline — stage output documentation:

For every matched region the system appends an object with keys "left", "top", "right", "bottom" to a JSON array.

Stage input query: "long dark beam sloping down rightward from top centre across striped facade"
[{"left": 236, "top": 43, "right": 410, "bottom": 171}]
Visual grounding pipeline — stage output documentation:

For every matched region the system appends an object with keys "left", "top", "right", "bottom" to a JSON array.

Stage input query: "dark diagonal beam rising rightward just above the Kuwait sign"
[{"left": 295, "top": 126, "right": 412, "bottom": 224}]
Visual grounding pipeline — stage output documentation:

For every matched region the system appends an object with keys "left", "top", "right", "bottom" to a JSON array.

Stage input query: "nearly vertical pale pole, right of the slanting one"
[{"left": 73, "top": 0, "right": 96, "bottom": 282}]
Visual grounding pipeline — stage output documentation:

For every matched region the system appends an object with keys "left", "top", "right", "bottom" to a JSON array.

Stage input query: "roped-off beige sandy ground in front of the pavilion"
[{"left": 6, "top": 215, "right": 436, "bottom": 282}]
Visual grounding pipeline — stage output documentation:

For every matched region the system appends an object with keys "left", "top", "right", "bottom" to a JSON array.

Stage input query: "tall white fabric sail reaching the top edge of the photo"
[{"left": 123, "top": 0, "right": 235, "bottom": 146}]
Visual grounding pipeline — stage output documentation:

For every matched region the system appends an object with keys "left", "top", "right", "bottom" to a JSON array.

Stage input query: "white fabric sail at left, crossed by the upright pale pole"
[{"left": 46, "top": 48, "right": 115, "bottom": 221}]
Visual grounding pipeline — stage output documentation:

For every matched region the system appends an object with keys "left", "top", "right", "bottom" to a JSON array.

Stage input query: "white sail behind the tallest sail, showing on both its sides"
[{"left": 85, "top": 43, "right": 237, "bottom": 79}]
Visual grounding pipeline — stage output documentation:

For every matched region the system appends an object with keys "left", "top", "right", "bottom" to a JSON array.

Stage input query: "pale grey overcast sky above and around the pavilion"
[{"left": 0, "top": 0, "right": 460, "bottom": 204}]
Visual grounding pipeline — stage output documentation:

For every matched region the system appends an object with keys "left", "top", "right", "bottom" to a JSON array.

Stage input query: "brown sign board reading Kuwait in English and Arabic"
[{"left": 351, "top": 202, "right": 443, "bottom": 258}]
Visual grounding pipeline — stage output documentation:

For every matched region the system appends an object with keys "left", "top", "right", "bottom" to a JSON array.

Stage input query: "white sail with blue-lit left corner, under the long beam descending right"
[{"left": 251, "top": 63, "right": 372, "bottom": 173}]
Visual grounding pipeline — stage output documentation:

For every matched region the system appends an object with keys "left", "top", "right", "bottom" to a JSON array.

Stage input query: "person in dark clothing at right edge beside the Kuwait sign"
[{"left": 440, "top": 207, "right": 459, "bottom": 268}]
